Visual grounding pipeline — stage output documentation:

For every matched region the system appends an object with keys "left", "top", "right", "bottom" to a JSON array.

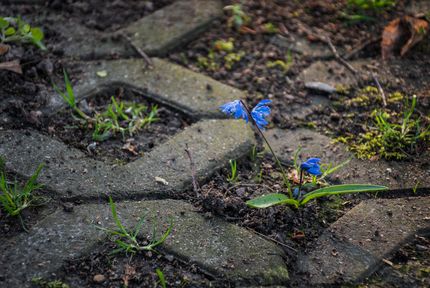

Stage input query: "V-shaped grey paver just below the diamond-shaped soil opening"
[{"left": 0, "top": 119, "right": 255, "bottom": 200}]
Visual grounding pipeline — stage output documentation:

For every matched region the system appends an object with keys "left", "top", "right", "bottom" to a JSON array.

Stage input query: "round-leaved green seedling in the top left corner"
[{"left": 0, "top": 17, "right": 46, "bottom": 50}]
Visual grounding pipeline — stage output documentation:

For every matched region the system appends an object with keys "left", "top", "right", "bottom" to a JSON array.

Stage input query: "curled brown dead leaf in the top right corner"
[{"left": 381, "top": 16, "right": 429, "bottom": 60}]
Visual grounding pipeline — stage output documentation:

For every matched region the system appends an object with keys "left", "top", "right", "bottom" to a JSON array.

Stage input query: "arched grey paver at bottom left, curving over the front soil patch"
[{"left": 0, "top": 200, "right": 288, "bottom": 287}]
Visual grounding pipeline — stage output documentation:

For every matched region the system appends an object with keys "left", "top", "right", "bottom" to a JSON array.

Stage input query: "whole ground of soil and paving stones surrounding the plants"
[{"left": 0, "top": 0, "right": 430, "bottom": 287}]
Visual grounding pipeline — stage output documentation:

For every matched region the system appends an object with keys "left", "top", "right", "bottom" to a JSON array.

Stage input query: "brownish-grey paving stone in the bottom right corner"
[{"left": 298, "top": 197, "right": 430, "bottom": 285}]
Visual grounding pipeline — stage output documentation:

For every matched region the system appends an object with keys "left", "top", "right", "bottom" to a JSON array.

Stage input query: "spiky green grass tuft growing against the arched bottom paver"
[{"left": 97, "top": 197, "right": 173, "bottom": 254}]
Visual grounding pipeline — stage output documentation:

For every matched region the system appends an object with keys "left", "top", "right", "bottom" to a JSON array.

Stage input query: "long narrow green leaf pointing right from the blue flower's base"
[{"left": 300, "top": 184, "right": 388, "bottom": 205}]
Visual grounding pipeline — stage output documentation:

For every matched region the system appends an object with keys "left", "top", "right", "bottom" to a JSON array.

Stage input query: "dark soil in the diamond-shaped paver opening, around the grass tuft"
[{"left": 39, "top": 88, "right": 191, "bottom": 164}]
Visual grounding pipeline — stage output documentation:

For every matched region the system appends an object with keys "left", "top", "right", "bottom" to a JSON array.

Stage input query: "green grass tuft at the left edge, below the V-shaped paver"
[{"left": 0, "top": 157, "right": 44, "bottom": 230}]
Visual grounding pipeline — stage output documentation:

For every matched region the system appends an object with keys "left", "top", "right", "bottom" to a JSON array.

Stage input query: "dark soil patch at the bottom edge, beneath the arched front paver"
[{"left": 63, "top": 243, "right": 218, "bottom": 288}]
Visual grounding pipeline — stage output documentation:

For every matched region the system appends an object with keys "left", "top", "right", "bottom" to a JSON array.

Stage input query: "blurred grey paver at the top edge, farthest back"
[{"left": 117, "top": 0, "right": 222, "bottom": 56}]
